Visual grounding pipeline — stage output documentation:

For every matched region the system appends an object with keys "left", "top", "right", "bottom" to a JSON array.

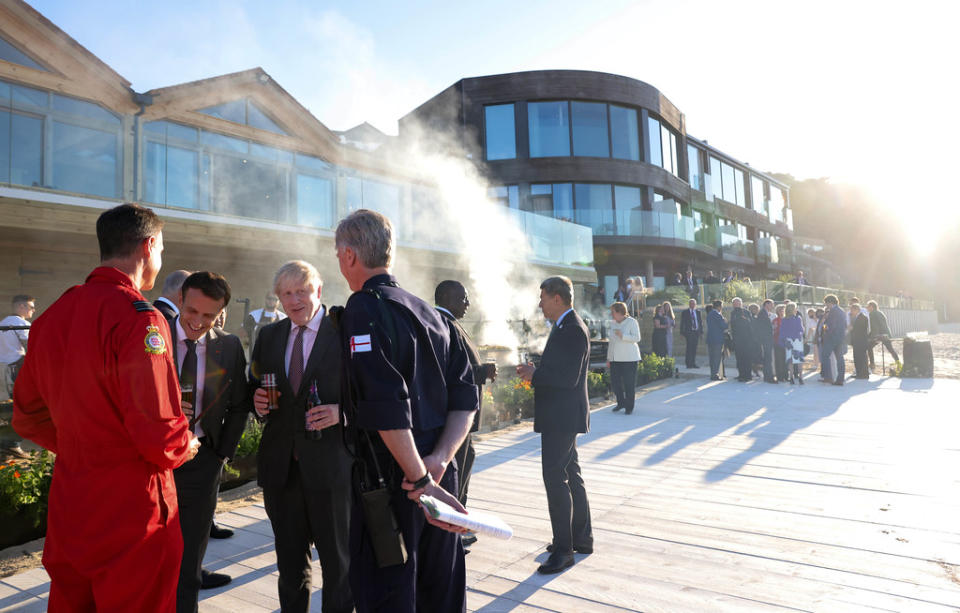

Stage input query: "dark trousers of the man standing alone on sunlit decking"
[{"left": 540, "top": 432, "right": 593, "bottom": 553}]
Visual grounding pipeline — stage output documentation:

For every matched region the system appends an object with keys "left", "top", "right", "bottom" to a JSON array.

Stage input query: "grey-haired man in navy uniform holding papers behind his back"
[{"left": 336, "top": 209, "right": 478, "bottom": 613}]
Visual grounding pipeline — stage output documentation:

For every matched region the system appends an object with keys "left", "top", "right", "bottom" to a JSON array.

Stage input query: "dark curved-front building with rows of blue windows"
[{"left": 400, "top": 70, "right": 794, "bottom": 304}]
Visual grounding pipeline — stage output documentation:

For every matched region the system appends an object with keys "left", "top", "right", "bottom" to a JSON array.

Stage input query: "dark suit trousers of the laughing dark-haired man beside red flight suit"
[{"left": 173, "top": 441, "right": 223, "bottom": 613}]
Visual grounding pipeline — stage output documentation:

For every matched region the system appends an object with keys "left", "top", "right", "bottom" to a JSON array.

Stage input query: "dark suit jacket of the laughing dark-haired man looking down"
[{"left": 168, "top": 318, "right": 253, "bottom": 459}]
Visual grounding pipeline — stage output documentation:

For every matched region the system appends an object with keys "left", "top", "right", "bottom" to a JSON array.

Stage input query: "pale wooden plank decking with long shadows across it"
[{"left": 0, "top": 377, "right": 960, "bottom": 613}]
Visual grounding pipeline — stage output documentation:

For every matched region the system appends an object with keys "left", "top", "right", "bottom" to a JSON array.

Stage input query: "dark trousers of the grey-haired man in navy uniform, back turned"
[{"left": 350, "top": 464, "right": 467, "bottom": 613}]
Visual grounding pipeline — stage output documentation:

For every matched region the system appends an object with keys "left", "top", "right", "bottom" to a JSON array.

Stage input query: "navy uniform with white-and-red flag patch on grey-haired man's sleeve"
[{"left": 340, "top": 275, "right": 479, "bottom": 613}]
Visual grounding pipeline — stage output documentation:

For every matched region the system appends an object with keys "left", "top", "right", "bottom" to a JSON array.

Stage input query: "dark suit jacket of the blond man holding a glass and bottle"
[{"left": 250, "top": 307, "right": 350, "bottom": 491}]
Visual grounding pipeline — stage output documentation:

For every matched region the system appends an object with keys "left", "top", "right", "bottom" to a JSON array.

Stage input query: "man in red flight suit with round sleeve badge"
[{"left": 13, "top": 204, "right": 199, "bottom": 613}]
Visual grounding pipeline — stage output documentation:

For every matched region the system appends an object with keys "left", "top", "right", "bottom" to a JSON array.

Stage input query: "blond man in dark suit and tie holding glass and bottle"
[{"left": 250, "top": 260, "right": 353, "bottom": 613}]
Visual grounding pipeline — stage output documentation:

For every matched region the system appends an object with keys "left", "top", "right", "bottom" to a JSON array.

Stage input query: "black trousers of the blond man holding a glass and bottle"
[{"left": 262, "top": 458, "right": 353, "bottom": 613}]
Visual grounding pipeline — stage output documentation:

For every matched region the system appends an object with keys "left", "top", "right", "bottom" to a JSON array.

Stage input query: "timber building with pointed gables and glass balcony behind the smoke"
[{"left": 0, "top": 0, "right": 596, "bottom": 329}]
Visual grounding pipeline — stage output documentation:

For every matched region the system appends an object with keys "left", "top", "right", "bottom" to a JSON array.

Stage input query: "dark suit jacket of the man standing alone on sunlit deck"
[{"left": 531, "top": 311, "right": 590, "bottom": 433}]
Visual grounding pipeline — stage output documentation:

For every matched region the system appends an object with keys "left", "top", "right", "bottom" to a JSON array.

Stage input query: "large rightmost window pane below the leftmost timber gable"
[{"left": 51, "top": 121, "right": 119, "bottom": 198}]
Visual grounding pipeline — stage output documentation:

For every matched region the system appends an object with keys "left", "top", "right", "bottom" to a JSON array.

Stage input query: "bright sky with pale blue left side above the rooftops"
[{"left": 33, "top": 0, "right": 960, "bottom": 248}]
